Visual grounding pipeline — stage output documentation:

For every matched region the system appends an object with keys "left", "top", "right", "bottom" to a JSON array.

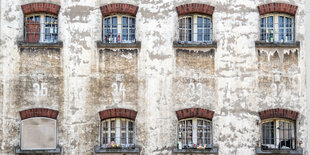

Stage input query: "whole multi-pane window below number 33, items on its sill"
[{"left": 178, "top": 118, "right": 212, "bottom": 149}]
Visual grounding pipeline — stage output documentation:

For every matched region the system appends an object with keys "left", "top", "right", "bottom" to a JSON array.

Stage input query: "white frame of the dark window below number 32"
[{"left": 261, "top": 118, "right": 296, "bottom": 150}]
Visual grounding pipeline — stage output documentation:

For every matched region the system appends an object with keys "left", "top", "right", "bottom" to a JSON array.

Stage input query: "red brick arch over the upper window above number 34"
[{"left": 100, "top": 3, "right": 139, "bottom": 17}]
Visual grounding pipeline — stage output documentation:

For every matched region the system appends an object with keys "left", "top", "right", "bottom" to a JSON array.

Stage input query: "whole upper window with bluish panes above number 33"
[{"left": 179, "top": 15, "right": 212, "bottom": 43}]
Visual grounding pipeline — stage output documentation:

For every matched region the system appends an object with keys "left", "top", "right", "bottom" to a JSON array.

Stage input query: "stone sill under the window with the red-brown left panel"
[{"left": 17, "top": 41, "right": 63, "bottom": 48}]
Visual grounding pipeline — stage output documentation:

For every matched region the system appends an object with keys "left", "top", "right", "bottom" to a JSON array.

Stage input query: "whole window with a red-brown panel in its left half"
[{"left": 25, "top": 14, "right": 58, "bottom": 43}]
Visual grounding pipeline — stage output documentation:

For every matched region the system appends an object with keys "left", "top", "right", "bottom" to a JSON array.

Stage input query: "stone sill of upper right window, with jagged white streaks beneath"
[{"left": 255, "top": 41, "right": 300, "bottom": 48}]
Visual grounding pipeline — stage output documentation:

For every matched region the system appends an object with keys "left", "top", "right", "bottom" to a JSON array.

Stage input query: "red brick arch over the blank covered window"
[{"left": 19, "top": 108, "right": 59, "bottom": 120}]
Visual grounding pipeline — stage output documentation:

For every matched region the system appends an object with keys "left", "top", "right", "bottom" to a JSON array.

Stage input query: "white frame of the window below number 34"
[{"left": 100, "top": 118, "right": 136, "bottom": 148}]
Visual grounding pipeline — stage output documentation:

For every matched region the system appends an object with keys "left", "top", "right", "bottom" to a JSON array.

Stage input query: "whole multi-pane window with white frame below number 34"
[{"left": 101, "top": 118, "right": 135, "bottom": 148}]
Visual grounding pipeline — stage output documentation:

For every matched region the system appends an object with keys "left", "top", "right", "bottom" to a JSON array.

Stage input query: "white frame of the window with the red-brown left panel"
[{"left": 24, "top": 14, "right": 59, "bottom": 43}]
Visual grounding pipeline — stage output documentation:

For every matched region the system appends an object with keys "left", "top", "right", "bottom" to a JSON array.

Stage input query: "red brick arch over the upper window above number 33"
[{"left": 176, "top": 3, "right": 214, "bottom": 16}]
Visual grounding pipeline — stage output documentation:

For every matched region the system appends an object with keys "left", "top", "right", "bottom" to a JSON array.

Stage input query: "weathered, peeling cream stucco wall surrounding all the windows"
[{"left": 0, "top": 0, "right": 308, "bottom": 155}]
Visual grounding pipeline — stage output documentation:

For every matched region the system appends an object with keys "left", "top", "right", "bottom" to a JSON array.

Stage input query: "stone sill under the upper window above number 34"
[{"left": 97, "top": 41, "right": 141, "bottom": 48}]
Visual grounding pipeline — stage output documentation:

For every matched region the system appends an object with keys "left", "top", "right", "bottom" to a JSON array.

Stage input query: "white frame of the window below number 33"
[{"left": 177, "top": 118, "right": 213, "bottom": 148}]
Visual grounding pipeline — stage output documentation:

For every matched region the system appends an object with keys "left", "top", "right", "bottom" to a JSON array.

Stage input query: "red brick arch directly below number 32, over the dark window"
[{"left": 258, "top": 108, "right": 298, "bottom": 121}]
